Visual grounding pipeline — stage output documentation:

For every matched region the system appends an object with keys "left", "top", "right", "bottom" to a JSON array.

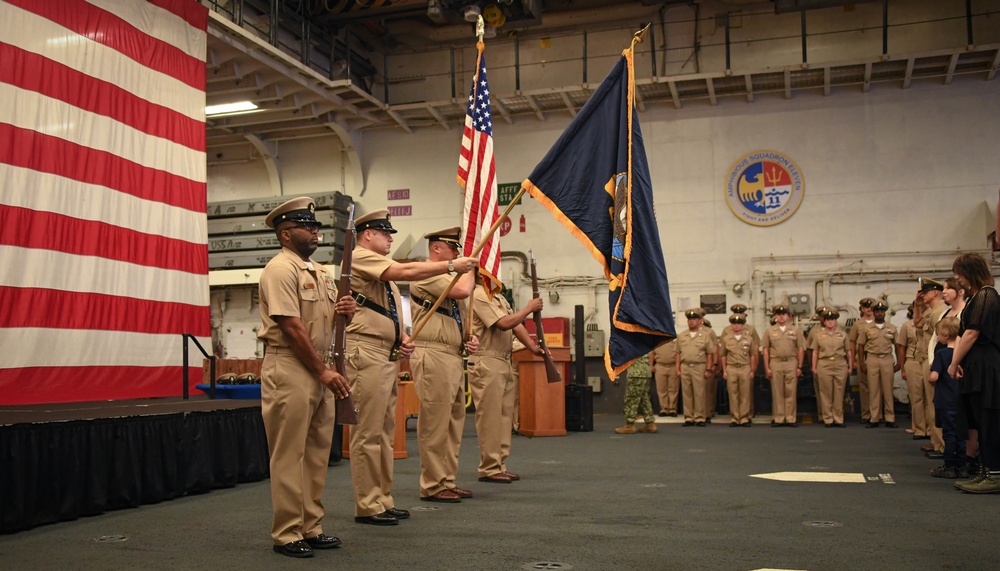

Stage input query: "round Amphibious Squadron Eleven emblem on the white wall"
[{"left": 726, "top": 150, "right": 805, "bottom": 226}]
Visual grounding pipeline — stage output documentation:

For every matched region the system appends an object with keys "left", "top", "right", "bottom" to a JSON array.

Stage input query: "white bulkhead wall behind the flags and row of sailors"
[{"left": 209, "top": 1, "right": 1000, "bottom": 344}]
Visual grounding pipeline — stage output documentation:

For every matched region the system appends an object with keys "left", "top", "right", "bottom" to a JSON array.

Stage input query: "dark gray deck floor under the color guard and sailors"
[{"left": 0, "top": 415, "right": 1000, "bottom": 571}]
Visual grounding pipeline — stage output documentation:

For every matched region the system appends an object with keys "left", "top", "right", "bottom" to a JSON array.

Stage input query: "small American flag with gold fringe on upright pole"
[{"left": 458, "top": 42, "right": 501, "bottom": 293}]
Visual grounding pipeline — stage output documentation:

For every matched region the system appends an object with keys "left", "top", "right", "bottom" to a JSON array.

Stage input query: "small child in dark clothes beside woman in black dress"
[{"left": 928, "top": 317, "right": 968, "bottom": 480}]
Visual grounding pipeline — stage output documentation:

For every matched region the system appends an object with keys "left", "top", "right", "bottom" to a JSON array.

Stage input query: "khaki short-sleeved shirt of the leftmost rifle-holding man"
[{"left": 257, "top": 248, "right": 338, "bottom": 355}]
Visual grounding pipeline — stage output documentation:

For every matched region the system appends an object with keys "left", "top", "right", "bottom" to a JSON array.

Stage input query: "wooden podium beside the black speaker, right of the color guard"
[{"left": 513, "top": 347, "right": 569, "bottom": 436}]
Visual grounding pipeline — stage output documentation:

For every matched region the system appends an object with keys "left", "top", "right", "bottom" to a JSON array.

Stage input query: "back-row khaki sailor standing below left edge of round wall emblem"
[{"left": 719, "top": 313, "right": 757, "bottom": 426}]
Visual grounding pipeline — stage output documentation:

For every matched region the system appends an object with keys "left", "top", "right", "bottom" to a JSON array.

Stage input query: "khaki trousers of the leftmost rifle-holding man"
[{"left": 260, "top": 347, "right": 335, "bottom": 545}]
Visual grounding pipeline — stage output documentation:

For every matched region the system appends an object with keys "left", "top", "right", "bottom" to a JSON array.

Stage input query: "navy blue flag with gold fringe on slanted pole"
[{"left": 521, "top": 50, "right": 676, "bottom": 379}]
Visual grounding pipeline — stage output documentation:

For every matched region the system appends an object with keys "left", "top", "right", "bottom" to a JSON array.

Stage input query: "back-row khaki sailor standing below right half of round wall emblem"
[{"left": 761, "top": 305, "right": 805, "bottom": 427}]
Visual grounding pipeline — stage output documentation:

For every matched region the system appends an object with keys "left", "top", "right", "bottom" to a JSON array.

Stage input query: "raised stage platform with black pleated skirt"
[{"left": 0, "top": 396, "right": 268, "bottom": 533}]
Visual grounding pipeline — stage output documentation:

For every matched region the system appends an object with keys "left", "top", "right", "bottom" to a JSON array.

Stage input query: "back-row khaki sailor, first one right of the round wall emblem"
[{"left": 810, "top": 308, "right": 852, "bottom": 428}]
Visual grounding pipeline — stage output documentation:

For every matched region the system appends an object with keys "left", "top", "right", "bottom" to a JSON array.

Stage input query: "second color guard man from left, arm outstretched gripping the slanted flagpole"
[{"left": 345, "top": 210, "right": 475, "bottom": 525}]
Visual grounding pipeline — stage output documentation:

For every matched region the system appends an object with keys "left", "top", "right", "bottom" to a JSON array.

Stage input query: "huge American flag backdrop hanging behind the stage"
[{"left": 0, "top": 0, "right": 211, "bottom": 405}]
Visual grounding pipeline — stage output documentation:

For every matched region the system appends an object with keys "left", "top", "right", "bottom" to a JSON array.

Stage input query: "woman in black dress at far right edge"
[{"left": 948, "top": 253, "right": 1000, "bottom": 494}]
